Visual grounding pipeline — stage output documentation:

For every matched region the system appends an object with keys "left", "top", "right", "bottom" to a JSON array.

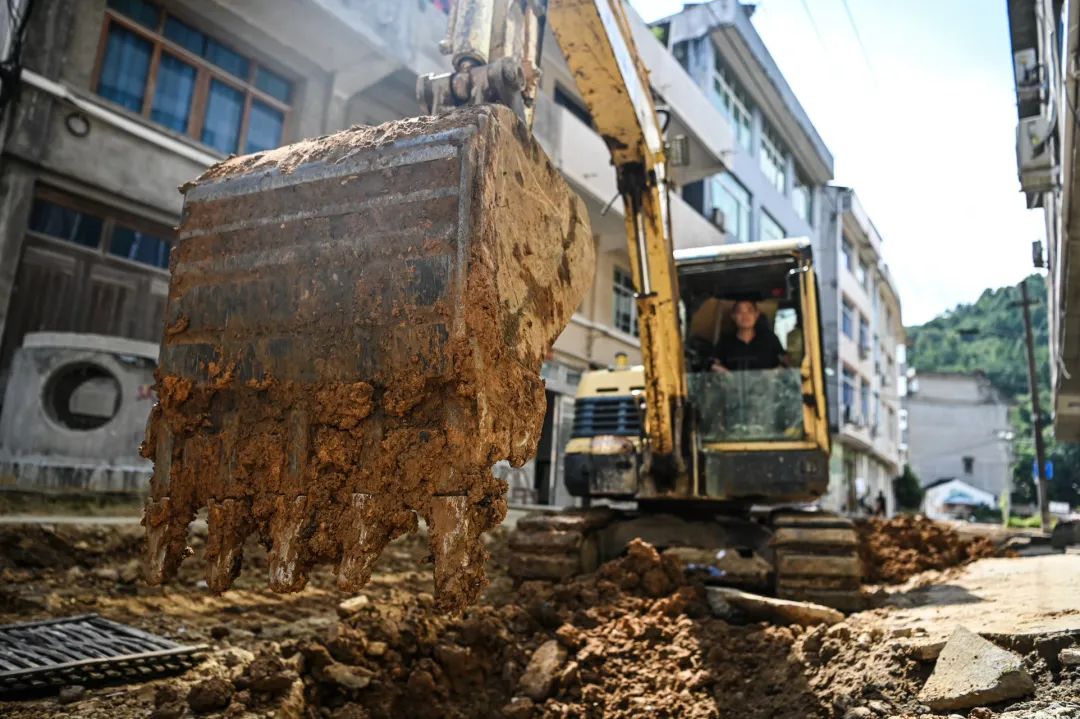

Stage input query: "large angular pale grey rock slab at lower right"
[{"left": 919, "top": 626, "right": 1035, "bottom": 711}]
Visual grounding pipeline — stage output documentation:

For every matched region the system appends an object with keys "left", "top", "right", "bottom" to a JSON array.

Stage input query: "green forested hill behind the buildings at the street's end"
[{"left": 907, "top": 274, "right": 1050, "bottom": 404}]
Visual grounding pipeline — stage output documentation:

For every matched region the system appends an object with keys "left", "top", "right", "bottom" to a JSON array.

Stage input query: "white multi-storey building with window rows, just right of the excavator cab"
[{"left": 816, "top": 187, "right": 905, "bottom": 512}]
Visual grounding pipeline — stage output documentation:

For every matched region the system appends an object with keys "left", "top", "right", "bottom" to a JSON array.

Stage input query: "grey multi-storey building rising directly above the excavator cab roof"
[{"left": 653, "top": 0, "right": 833, "bottom": 244}]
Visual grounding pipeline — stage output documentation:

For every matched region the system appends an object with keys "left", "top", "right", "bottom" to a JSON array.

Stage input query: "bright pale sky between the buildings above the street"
[{"left": 631, "top": 0, "right": 1044, "bottom": 325}]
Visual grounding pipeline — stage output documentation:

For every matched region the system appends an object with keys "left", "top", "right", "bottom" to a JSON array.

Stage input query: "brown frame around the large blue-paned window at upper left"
[{"left": 90, "top": 2, "right": 297, "bottom": 154}]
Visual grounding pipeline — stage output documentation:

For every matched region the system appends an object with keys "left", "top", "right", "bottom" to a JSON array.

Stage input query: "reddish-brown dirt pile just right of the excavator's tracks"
[{"left": 856, "top": 515, "right": 1002, "bottom": 584}]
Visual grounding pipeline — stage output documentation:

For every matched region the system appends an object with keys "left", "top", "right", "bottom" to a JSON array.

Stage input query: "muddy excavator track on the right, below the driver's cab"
[{"left": 771, "top": 512, "right": 863, "bottom": 612}]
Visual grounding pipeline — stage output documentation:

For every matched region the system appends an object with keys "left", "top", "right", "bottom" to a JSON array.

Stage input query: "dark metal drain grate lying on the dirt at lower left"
[{"left": 0, "top": 614, "right": 206, "bottom": 694}]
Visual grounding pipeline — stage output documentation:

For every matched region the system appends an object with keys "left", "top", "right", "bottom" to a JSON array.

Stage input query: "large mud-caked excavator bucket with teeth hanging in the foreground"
[{"left": 143, "top": 106, "right": 593, "bottom": 610}]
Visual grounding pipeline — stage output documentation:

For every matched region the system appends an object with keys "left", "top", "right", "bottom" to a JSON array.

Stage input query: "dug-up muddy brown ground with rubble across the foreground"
[{"left": 0, "top": 513, "right": 1080, "bottom": 719}]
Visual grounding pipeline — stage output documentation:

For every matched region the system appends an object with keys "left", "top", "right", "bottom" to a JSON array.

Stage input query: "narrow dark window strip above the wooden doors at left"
[{"left": 28, "top": 198, "right": 171, "bottom": 270}]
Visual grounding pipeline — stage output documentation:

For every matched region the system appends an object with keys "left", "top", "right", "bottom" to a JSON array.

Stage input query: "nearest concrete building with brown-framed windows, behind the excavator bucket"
[{"left": 0, "top": 0, "right": 732, "bottom": 501}]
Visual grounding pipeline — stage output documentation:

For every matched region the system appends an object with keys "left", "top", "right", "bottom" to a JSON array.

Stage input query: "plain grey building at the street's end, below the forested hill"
[{"left": 905, "top": 372, "right": 1012, "bottom": 498}]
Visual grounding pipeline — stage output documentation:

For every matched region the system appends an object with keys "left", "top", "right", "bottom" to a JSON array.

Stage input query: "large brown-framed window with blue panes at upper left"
[{"left": 95, "top": 0, "right": 293, "bottom": 154}]
